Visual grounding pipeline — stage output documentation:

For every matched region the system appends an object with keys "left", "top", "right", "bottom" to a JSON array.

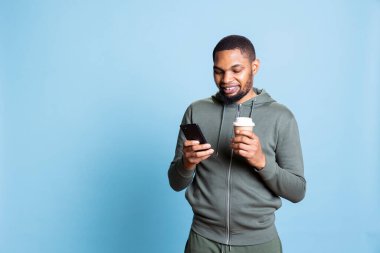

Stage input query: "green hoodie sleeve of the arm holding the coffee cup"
[{"left": 258, "top": 113, "right": 306, "bottom": 203}]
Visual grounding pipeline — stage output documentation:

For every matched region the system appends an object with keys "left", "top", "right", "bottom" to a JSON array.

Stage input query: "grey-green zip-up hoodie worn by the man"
[{"left": 168, "top": 88, "right": 306, "bottom": 245}]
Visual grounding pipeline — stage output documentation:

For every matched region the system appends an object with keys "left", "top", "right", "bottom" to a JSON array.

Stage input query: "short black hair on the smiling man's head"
[{"left": 212, "top": 35, "right": 256, "bottom": 62}]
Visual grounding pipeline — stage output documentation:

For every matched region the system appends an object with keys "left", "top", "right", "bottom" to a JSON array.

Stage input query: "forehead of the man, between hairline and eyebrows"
[{"left": 214, "top": 48, "right": 249, "bottom": 66}]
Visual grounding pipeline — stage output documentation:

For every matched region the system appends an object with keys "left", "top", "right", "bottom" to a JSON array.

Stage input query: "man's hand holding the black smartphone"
[{"left": 183, "top": 140, "right": 214, "bottom": 170}]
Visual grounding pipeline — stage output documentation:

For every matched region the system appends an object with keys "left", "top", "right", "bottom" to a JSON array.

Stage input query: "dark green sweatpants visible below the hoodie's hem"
[{"left": 185, "top": 230, "right": 282, "bottom": 253}]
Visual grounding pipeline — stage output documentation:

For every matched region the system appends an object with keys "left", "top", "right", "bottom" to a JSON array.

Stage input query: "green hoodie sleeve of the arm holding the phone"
[{"left": 168, "top": 107, "right": 195, "bottom": 191}]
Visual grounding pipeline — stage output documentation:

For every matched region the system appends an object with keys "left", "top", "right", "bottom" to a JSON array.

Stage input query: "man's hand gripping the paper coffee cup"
[{"left": 231, "top": 130, "right": 266, "bottom": 170}]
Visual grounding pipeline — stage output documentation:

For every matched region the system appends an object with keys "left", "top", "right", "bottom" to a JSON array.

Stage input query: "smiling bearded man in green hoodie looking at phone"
[{"left": 168, "top": 35, "right": 306, "bottom": 253}]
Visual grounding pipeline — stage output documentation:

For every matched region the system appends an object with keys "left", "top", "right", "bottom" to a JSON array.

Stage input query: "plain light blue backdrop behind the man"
[{"left": 0, "top": 0, "right": 380, "bottom": 253}]
